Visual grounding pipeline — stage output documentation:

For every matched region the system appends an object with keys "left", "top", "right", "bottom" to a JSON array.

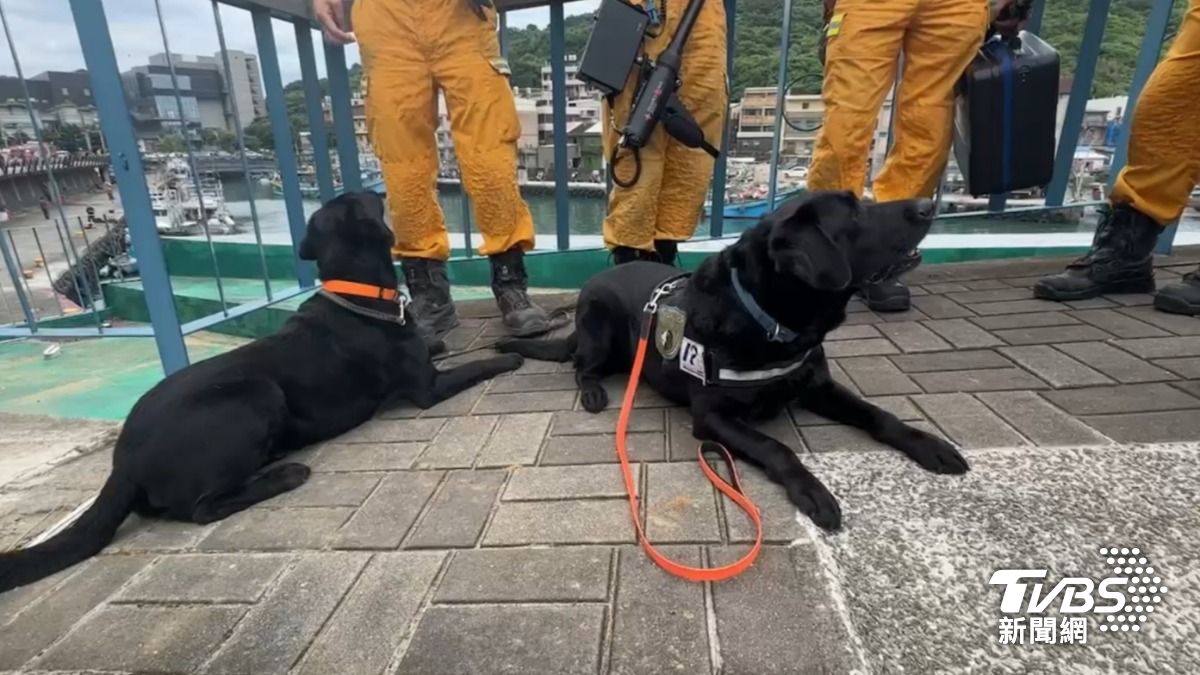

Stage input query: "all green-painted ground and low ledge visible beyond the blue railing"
[{"left": 0, "top": 241, "right": 1089, "bottom": 419}]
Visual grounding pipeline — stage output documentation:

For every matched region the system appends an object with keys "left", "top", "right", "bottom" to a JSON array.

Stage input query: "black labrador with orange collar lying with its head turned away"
[{"left": 0, "top": 192, "right": 523, "bottom": 591}]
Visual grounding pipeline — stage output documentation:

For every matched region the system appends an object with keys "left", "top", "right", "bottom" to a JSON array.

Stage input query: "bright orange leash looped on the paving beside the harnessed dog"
[{"left": 617, "top": 305, "right": 762, "bottom": 581}]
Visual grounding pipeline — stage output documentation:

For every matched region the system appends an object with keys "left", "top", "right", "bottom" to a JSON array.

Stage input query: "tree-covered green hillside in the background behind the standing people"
[{"left": 508, "top": 0, "right": 1187, "bottom": 98}]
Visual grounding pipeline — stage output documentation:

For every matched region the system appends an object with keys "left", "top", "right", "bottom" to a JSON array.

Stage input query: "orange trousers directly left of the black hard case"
[{"left": 808, "top": 0, "right": 991, "bottom": 202}]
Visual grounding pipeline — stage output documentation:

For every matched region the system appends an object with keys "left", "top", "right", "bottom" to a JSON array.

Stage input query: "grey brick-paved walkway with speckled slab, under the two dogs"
[{"left": 0, "top": 255, "right": 1200, "bottom": 675}]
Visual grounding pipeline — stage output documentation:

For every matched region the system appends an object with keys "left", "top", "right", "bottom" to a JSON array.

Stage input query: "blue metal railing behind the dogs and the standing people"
[{"left": 0, "top": 0, "right": 1172, "bottom": 372}]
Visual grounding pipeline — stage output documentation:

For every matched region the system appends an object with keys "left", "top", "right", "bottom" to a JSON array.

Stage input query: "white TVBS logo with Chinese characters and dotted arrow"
[{"left": 989, "top": 546, "right": 1166, "bottom": 644}]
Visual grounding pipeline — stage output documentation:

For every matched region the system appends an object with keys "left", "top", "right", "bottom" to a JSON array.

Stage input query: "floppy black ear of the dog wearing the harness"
[{"left": 768, "top": 202, "right": 853, "bottom": 291}]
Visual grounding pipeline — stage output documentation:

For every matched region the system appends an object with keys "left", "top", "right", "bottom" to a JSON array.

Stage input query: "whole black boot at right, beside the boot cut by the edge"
[{"left": 1033, "top": 204, "right": 1163, "bottom": 301}]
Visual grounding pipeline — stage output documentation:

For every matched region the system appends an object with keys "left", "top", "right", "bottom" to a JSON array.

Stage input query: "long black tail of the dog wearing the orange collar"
[{"left": 0, "top": 472, "right": 139, "bottom": 593}]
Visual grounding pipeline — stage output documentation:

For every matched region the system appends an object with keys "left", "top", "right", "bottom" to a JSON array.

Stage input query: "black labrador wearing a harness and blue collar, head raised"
[{"left": 498, "top": 192, "right": 967, "bottom": 530}]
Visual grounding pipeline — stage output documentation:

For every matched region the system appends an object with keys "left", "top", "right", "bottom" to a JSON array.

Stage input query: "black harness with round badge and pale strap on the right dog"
[{"left": 642, "top": 271, "right": 812, "bottom": 387}]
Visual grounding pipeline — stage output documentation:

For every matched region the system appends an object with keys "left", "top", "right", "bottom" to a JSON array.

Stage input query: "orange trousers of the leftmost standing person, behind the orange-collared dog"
[{"left": 352, "top": 0, "right": 534, "bottom": 261}]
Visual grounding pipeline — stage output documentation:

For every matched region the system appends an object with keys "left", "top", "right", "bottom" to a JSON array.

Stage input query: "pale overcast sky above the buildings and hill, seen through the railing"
[{"left": 0, "top": 0, "right": 599, "bottom": 83}]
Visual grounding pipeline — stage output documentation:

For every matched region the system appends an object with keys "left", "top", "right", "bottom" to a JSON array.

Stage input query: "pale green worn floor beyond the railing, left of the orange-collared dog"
[{"left": 0, "top": 333, "right": 246, "bottom": 419}]
